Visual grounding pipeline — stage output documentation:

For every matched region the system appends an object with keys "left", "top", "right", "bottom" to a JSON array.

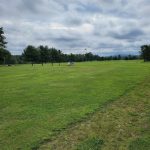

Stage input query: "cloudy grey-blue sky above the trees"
[{"left": 0, "top": 0, "right": 150, "bottom": 56}]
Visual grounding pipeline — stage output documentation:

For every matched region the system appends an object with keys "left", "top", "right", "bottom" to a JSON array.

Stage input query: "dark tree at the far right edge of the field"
[{"left": 141, "top": 45, "right": 150, "bottom": 61}]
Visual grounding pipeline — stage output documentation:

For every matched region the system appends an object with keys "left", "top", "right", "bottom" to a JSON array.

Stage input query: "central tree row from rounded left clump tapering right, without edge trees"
[{"left": 22, "top": 45, "right": 139, "bottom": 65}]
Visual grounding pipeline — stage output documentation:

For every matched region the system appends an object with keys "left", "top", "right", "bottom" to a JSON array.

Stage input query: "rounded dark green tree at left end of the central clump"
[{"left": 23, "top": 45, "right": 40, "bottom": 66}]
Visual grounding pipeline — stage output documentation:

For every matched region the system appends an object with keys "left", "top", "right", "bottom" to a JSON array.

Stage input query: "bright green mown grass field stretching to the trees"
[{"left": 0, "top": 61, "right": 150, "bottom": 150}]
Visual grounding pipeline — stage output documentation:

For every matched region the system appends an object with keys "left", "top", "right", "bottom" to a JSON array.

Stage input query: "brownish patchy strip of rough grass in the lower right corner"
[{"left": 40, "top": 80, "right": 150, "bottom": 150}]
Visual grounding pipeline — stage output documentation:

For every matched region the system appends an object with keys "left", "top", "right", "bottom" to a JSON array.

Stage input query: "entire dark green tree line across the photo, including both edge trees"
[{"left": 0, "top": 27, "right": 150, "bottom": 65}]
